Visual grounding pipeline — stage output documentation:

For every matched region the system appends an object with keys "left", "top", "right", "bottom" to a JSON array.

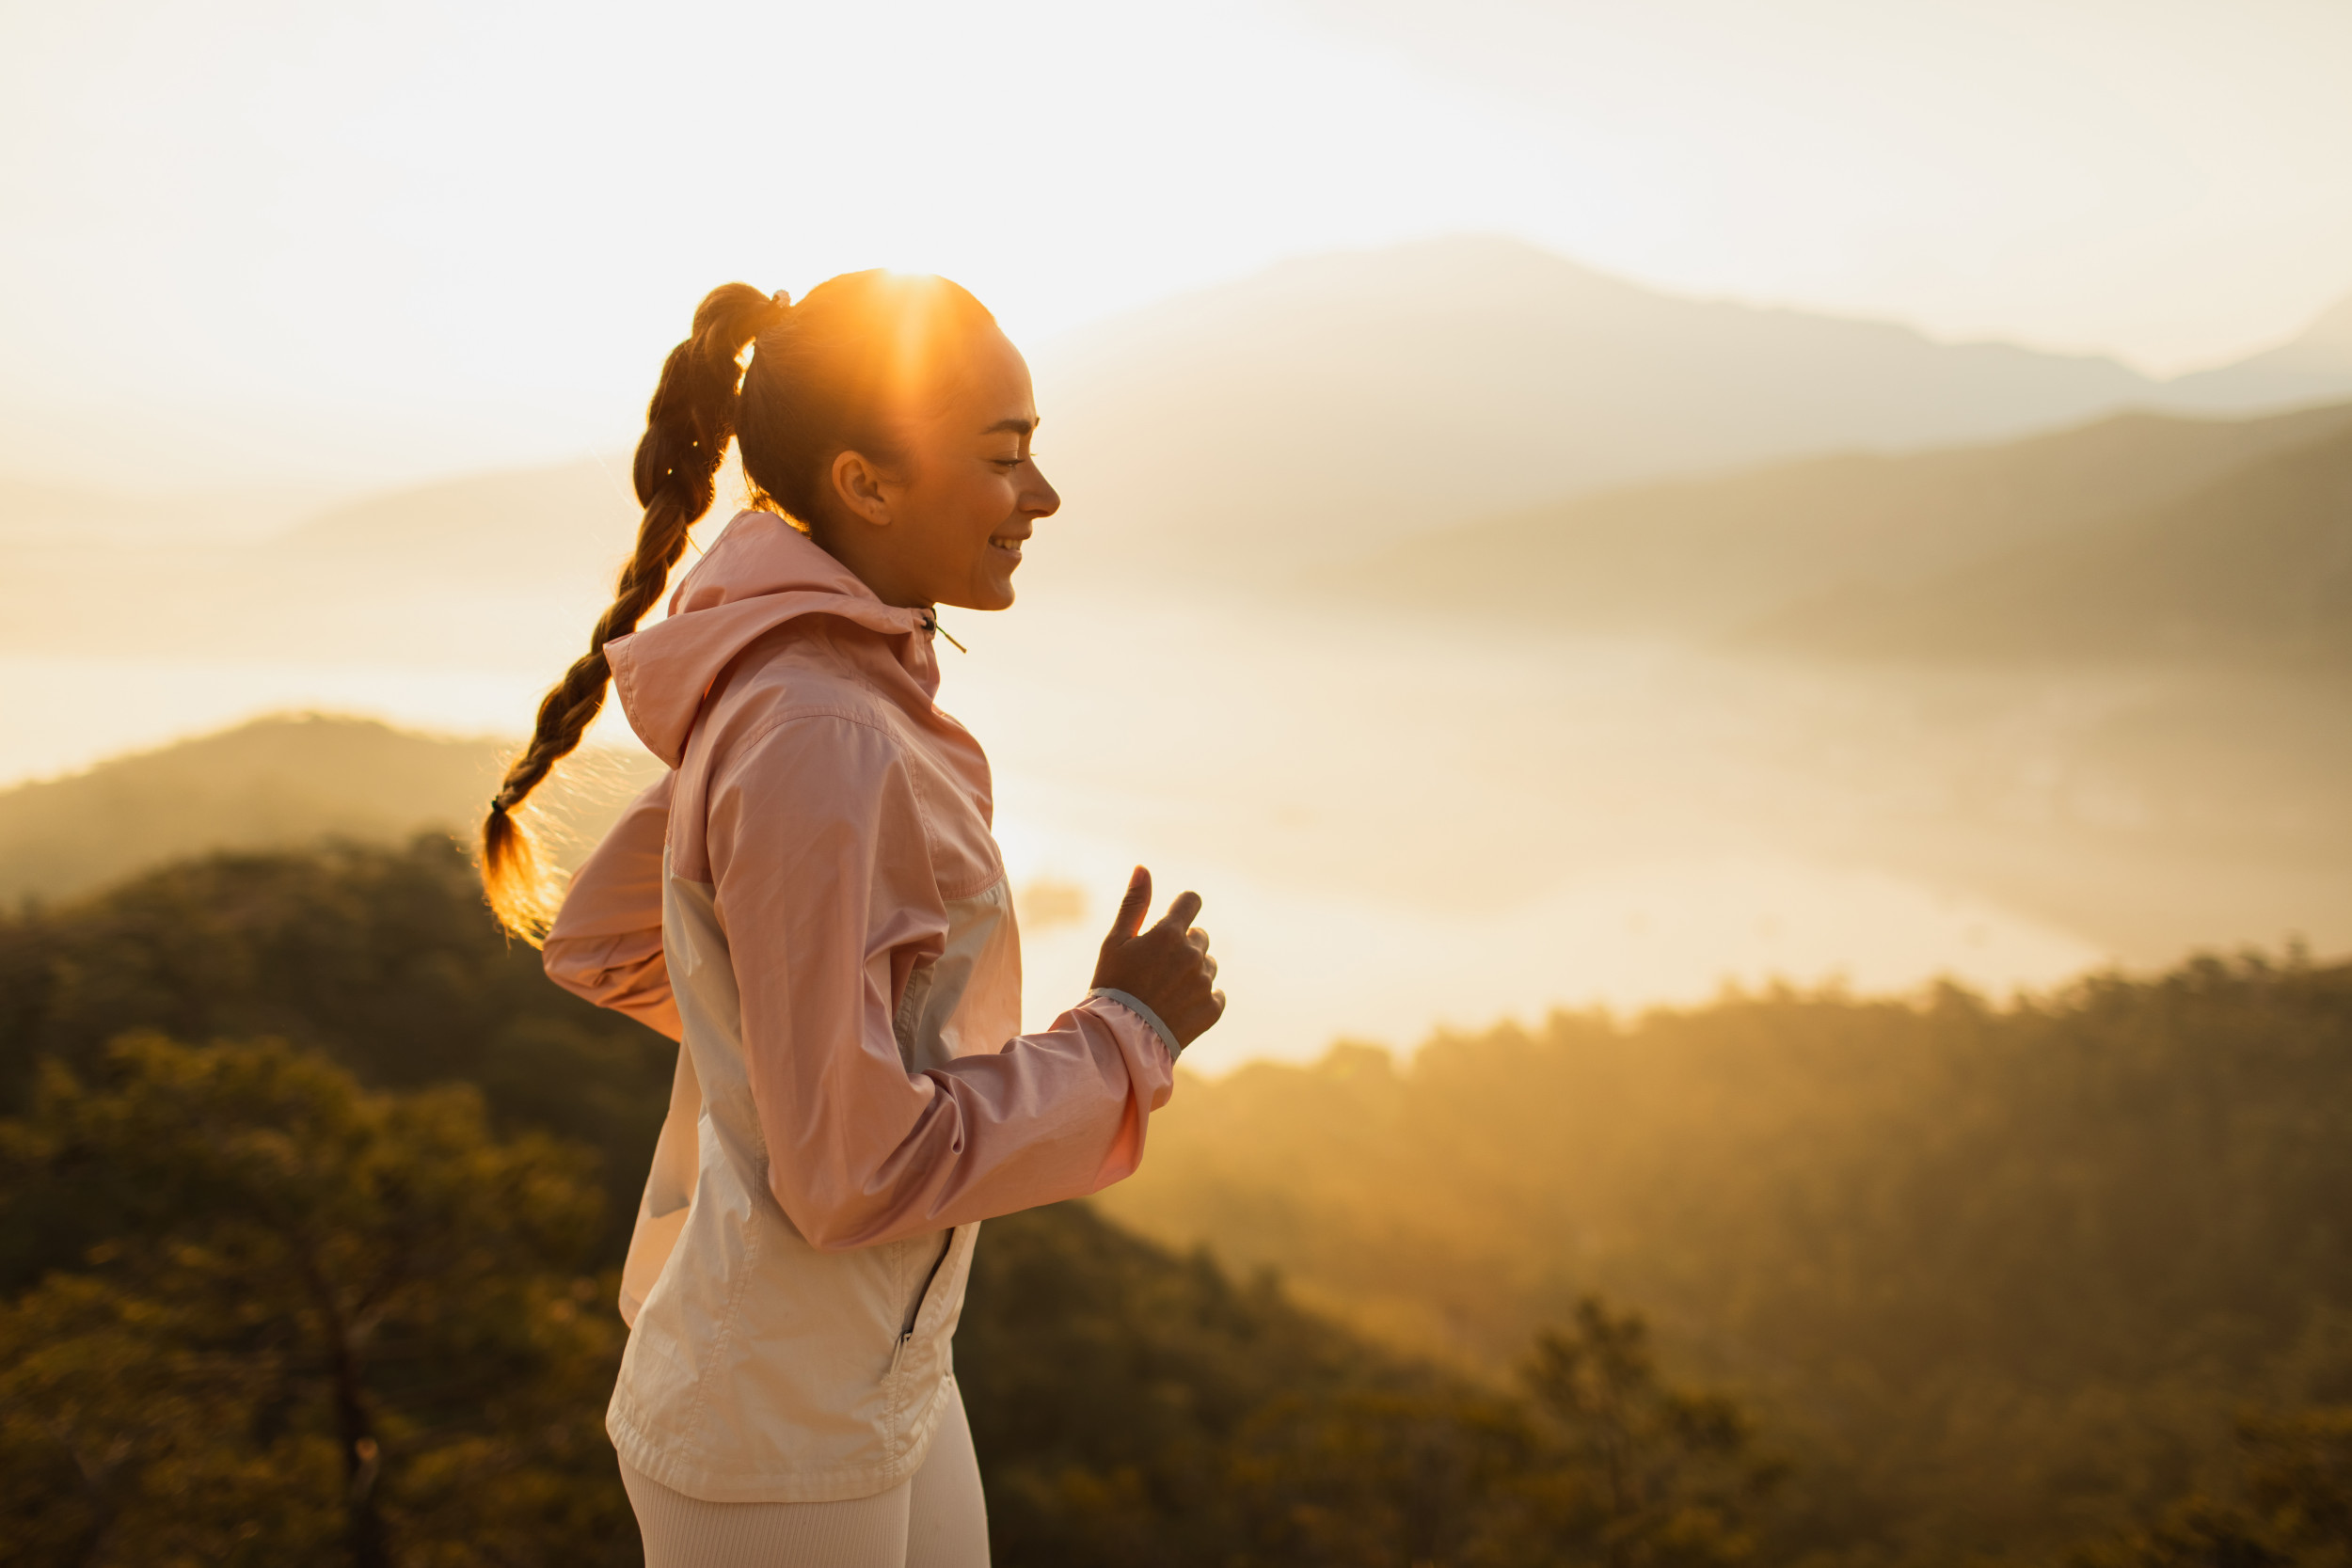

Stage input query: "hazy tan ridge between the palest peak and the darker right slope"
[{"left": 1306, "top": 404, "right": 2352, "bottom": 635}]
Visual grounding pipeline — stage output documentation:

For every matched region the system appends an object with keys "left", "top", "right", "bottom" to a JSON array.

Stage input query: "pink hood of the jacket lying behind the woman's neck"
[{"left": 605, "top": 513, "right": 939, "bottom": 768}]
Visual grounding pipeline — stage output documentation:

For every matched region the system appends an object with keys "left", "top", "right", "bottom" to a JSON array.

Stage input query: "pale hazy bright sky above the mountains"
[{"left": 13, "top": 0, "right": 2352, "bottom": 484}]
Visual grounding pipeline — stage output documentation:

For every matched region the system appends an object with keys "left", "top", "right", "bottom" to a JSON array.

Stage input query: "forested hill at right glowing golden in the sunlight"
[{"left": 1104, "top": 959, "right": 2352, "bottom": 1561}]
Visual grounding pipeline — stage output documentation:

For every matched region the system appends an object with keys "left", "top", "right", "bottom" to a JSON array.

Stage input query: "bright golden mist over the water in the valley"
[{"left": 0, "top": 582, "right": 2164, "bottom": 1072}]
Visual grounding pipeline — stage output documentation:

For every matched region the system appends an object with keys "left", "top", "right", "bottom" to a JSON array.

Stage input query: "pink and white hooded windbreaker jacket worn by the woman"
[{"left": 546, "top": 513, "right": 1174, "bottom": 1502}]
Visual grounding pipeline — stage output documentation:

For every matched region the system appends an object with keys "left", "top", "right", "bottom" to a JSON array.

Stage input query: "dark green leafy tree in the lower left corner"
[{"left": 0, "top": 1035, "right": 635, "bottom": 1568}]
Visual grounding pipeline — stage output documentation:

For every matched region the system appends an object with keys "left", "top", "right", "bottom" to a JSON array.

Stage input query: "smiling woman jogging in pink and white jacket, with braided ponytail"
[{"left": 483, "top": 273, "right": 1226, "bottom": 1568}]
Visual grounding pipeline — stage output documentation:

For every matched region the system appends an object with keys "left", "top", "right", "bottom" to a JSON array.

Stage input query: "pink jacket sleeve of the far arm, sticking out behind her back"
[{"left": 541, "top": 773, "right": 685, "bottom": 1039}]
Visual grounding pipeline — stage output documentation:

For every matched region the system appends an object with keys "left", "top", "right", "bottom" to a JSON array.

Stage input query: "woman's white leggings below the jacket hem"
[{"left": 621, "top": 1385, "right": 988, "bottom": 1568}]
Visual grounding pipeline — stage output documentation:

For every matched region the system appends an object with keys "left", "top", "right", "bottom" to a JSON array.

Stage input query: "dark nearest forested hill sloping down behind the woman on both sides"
[{"left": 0, "top": 834, "right": 1811, "bottom": 1568}]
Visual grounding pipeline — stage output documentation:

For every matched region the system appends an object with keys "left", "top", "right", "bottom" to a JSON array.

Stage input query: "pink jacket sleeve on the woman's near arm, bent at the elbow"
[{"left": 708, "top": 715, "right": 1174, "bottom": 1251}]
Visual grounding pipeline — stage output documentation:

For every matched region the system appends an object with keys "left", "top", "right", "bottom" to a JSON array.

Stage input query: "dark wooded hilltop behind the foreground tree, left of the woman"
[{"left": 0, "top": 834, "right": 677, "bottom": 1289}]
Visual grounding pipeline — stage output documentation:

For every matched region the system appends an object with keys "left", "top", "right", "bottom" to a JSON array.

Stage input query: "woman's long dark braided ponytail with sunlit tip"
[{"left": 483, "top": 282, "right": 786, "bottom": 945}]
